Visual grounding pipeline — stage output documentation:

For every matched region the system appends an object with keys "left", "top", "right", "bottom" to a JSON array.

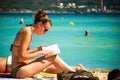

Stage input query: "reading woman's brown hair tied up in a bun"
[{"left": 34, "top": 9, "right": 52, "bottom": 25}]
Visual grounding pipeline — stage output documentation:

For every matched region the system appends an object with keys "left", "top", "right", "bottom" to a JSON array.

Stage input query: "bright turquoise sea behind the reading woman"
[{"left": 0, "top": 13, "right": 120, "bottom": 68}]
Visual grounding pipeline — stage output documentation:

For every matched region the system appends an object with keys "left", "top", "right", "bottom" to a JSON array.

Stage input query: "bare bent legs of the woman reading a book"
[{"left": 16, "top": 55, "right": 85, "bottom": 78}]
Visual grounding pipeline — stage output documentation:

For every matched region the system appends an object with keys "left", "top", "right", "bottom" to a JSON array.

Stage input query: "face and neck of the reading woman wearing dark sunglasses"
[{"left": 36, "top": 22, "right": 51, "bottom": 35}]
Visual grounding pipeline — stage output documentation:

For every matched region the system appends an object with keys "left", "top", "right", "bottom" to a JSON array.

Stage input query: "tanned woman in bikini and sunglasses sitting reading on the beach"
[{"left": 11, "top": 9, "right": 84, "bottom": 78}]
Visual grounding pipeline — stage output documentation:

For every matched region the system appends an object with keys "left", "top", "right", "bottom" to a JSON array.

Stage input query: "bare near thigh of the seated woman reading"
[{"left": 16, "top": 56, "right": 56, "bottom": 78}]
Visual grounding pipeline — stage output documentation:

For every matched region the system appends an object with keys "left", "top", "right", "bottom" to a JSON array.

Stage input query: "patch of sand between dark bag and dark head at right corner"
[{"left": 88, "top": 68, "right": 112, "bottom": 80}]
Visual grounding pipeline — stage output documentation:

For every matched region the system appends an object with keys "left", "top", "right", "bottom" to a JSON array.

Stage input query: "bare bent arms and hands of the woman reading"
[{"left": 18, "top": 32, "right": 55, "bottom": 62}]
